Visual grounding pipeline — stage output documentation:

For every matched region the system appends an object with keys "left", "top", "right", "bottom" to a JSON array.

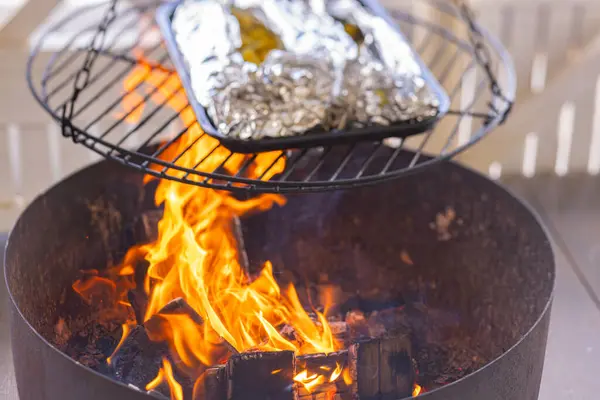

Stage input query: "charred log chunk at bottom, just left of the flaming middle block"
[{"left": 225, "top": 351, "right": 296, "bottom": 400}]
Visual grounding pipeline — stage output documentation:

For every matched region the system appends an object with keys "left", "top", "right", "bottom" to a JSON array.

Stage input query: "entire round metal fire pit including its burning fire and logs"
[{"left": 6, "top": 149, "right": 554, "bottom": 400}]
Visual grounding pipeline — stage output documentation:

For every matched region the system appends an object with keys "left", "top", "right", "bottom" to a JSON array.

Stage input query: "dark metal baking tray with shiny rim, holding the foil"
[{"left": 156, "top": 0, "right": 450, "bottom": 153}]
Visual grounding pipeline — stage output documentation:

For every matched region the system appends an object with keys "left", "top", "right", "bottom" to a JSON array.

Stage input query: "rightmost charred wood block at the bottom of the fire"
[{"left": 349, "top": 336, "right": 415, "bottom": 400}]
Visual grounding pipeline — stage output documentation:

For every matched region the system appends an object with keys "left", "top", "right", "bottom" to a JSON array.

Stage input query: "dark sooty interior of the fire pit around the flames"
[{"left": 7, "top": 150, "right": 554, "bottom": 399}]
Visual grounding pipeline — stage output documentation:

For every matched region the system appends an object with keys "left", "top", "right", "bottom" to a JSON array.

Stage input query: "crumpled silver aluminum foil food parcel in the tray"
[{"left": 172, "top": 0, "right": 438, "bottom": 139}]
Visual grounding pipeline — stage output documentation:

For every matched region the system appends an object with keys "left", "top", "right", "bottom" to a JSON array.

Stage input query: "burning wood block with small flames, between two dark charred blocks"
[{"left": 296, "top": 350, "right": 352, "bottom": 400}]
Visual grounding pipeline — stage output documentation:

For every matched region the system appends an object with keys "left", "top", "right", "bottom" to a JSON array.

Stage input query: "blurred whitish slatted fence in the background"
[{"left": 0, "top": 0, "right": 600, "bottom": 230}]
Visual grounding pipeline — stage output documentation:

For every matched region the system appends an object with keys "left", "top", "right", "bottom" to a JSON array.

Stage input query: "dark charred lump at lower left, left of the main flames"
[{"left": 111, "top": 325, "right": 168, "bottom": 388}]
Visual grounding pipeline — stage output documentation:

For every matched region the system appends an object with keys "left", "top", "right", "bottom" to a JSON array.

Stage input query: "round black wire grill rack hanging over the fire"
[{"left": 27, "top": 0, "right": 516, "bottom": 193}]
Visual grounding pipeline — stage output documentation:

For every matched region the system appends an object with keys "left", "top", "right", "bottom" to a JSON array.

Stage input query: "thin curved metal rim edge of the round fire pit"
[{"left": 3, "top": 160, "right": 556, "bottom": 400}]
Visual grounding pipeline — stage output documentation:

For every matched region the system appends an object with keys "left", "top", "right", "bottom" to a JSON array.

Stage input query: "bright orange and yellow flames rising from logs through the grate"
[{"left": 73, "top": 56, "right": 348, "bottom": 400}]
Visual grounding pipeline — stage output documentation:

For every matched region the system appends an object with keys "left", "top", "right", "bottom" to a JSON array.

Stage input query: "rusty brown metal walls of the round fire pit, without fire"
[{"left": 5, "top": 150, "right": 555, "bottom": 400}]
